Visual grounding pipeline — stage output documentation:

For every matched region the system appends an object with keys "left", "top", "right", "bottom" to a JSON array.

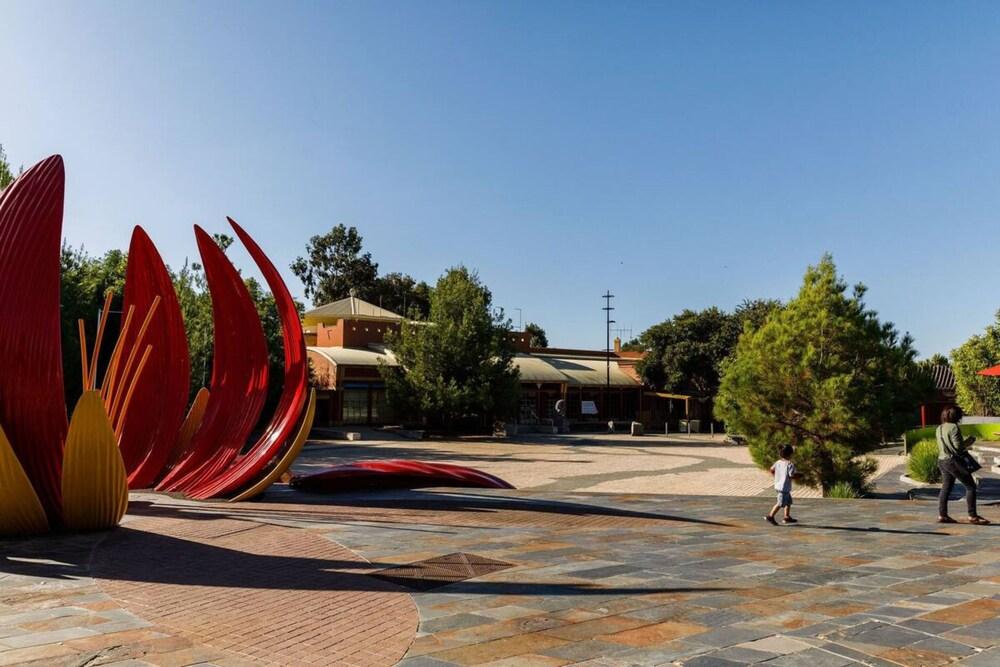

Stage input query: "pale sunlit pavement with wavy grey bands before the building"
[{"left": 295, "top": 431, "right": 903, "bottom": 497}]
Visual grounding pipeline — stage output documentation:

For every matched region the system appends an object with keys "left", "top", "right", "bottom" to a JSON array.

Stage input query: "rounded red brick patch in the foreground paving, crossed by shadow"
[{"left": 91, "top": 517, "right": 417, "bottom": 667}]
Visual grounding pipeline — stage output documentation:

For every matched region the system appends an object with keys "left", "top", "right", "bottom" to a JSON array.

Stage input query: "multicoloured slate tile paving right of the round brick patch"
[{"left": 248, "top": 491, "right": 1000, "bottom": 667}]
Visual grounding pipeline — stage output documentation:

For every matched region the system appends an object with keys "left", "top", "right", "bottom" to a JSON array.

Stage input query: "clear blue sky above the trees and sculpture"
[{"left": 0, "top": 0, "right": 1000, "bottom": 355}]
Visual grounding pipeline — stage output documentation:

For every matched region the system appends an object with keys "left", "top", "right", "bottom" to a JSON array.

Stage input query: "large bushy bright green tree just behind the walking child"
[{"left": 715, "top": 255, "right": 933, "bottom": 493}]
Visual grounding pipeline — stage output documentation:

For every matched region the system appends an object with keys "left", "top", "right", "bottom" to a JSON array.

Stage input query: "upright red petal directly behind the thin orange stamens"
[{"left": 118, "top": 226, "right": 191, "bottom": 489}]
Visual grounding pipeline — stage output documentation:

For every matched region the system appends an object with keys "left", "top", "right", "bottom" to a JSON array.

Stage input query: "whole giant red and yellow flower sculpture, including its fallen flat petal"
[{"left": 0, "top": 156, "right": 511, "bottom": 535}]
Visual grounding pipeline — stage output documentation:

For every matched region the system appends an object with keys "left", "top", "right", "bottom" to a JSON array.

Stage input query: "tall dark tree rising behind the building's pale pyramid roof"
[{"left": 292, "top": 225, "right": 378, "bottom": 306}]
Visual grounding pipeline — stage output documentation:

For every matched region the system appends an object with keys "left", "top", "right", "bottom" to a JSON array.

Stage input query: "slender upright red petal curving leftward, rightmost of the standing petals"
[{"left": 191, "top": 218, "right": 308, "bottom": 499}]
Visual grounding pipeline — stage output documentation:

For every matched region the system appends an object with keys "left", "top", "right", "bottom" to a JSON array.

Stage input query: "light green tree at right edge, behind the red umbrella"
[{"left": 951, "top": 311, "right": 1000, "bottom": 415}]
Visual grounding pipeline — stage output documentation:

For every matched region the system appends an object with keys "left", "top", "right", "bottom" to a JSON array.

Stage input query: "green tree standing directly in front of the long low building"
[{"left": 380, "top": 266, "right": 520, "bottom": 431}]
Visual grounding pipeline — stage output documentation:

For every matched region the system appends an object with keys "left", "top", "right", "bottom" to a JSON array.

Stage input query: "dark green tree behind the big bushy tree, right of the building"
[{"left": 638, "top": 299, "right": 780, "bottom": 396}]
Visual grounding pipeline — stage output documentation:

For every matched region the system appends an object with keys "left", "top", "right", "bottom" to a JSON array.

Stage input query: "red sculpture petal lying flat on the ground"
[{"left": 291, "top": 459, "right": 514, "bottom": 493}]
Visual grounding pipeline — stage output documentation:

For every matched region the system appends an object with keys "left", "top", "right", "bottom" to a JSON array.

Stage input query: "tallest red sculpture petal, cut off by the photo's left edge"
[{"left": 0, "top": 155, "right": 68, "bottom": 523}]
